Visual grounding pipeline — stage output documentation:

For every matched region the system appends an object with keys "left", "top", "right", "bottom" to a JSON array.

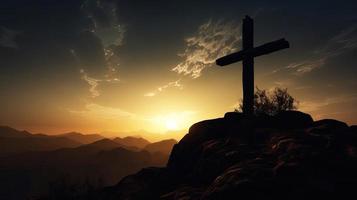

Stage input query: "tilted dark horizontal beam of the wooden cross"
[{"left": 216, "top": 38, "right": 290, "bottom": 66}]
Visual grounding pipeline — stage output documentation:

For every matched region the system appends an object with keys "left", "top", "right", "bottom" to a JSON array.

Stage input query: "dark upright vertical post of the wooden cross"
[{"left": 242, "top": 16, "right": 254, "bottom": 115}]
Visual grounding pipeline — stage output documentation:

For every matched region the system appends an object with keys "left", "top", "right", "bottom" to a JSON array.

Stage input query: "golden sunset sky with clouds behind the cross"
[{"left": 0, "top": 0, "right": 357, "bottom": 136}]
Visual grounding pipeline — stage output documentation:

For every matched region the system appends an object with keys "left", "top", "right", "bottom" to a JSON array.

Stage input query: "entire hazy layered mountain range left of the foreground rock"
[{"left": 0, "top": 126, "right": 177, "bottom": 199}]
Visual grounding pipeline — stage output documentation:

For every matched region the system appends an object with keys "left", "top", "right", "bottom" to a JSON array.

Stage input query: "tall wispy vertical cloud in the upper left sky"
[{"left": 70, "top": 0, "right": 126, "bottom": 98}]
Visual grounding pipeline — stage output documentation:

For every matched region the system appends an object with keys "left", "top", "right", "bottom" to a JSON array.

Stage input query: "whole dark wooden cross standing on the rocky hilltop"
[{"left": 216, "top": 15, "right": 289, "bottom": 115}]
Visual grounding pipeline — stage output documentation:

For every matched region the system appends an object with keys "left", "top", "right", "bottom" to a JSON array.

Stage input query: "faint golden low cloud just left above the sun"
[{"left": 69, "top": 103, "right": 136, "bottom": 120}]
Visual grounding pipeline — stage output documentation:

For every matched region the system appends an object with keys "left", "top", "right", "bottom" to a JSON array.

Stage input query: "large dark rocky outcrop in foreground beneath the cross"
[{"left": 92, "top": 111, "right": 357, "bottom": 200}]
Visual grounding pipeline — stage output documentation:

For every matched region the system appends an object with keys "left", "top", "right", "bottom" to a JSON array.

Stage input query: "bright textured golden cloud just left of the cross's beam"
[{"left": 172, "top": 20, "right": 241, "bottom": 78}]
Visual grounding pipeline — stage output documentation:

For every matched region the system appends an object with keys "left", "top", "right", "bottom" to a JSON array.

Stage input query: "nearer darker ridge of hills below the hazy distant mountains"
[{"left": 0, "top": 138, "right": 168, "bottom": 199}]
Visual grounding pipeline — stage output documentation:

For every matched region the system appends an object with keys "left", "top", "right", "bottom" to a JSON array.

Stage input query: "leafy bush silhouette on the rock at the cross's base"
[{"left": 235, "top": 87, "right": 297, "bottom": 115}]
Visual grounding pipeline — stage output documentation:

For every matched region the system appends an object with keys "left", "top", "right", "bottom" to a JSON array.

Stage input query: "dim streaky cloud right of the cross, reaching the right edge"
[{"left": 284, "top": 24, "right": 357, "bottom": 75}]
